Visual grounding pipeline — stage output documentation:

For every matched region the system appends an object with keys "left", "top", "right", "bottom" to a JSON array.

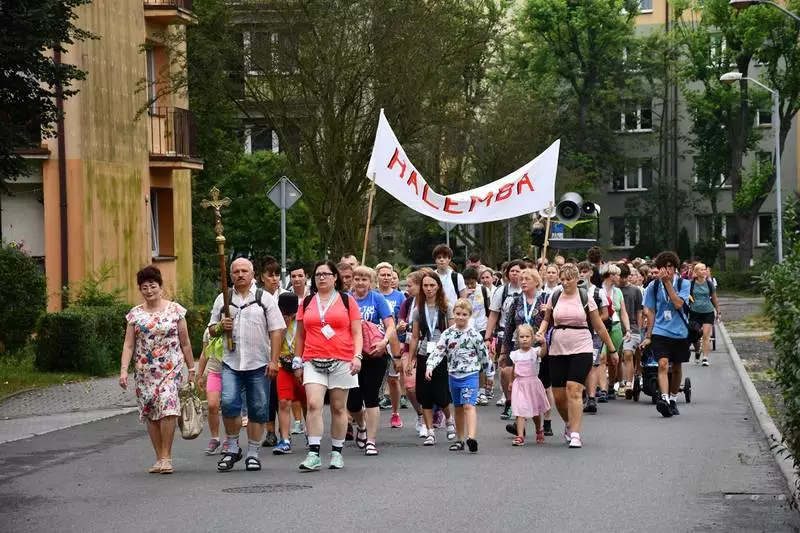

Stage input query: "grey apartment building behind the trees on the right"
[{"left": 598, "top": 0, "right": 800, "bottom": 259}]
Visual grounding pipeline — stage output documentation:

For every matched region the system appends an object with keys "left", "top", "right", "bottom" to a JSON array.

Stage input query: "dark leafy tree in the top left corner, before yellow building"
[{"left": 0, "top": 0, "right": 92, "bottom": 179}]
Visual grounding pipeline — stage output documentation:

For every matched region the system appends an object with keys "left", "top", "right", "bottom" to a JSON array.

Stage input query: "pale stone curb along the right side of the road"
[{"left": 717, "top": 322, "right": 800, "bottom": 503}]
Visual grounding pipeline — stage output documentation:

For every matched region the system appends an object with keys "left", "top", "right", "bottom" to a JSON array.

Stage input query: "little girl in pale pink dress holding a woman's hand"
[{"left": 510, "top": 324, "right": 550, "bottom": 446}]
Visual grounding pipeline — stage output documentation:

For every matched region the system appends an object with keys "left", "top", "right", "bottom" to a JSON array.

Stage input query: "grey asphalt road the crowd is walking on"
[{"left": 0, "top": 332, "right": 800, "bottom": 533}]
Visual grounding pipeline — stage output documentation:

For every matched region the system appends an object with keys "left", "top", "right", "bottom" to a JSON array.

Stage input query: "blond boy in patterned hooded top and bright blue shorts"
[{"left": 425, "top": 298, "right": 489, "bottom": 453}]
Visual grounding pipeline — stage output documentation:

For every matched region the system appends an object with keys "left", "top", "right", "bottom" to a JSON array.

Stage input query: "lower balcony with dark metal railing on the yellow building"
[{"left": 148, "top": 106, "right": 203, "bottom": 170}]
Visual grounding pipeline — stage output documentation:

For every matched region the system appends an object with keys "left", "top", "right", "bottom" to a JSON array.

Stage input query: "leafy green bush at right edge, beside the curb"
[{"left": 763, "top": 254, "right": 800, "bottom": 476}]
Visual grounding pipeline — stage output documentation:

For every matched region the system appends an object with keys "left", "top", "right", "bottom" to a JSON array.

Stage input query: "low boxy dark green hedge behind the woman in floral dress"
[{"left": 35, "top": 304, "right": 130, "bottom": 376}]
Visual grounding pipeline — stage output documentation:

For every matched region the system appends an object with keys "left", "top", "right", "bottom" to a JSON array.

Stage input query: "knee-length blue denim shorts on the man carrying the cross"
[{"left": 221, "top": 363, "right": 270, "bottom": 424}]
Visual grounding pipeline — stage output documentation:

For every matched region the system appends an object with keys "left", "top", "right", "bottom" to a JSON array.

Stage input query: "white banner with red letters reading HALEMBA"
[{"left": 367, "top": 110, "right": 561, "bottom": 224}]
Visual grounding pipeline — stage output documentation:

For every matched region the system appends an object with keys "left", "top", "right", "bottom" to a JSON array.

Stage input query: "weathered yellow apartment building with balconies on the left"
[{"left": 0, "top": 0, "right": 203, "bottom": 310}]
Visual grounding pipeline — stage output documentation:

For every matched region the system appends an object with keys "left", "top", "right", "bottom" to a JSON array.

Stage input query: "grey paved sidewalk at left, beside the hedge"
[{"left": 0, "top": 377, "right": 136, "bottom": 444}]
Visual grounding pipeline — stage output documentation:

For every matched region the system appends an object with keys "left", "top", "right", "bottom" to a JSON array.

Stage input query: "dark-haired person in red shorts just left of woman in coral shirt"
[{"left": 272, "top": 292, "right": 306, "bottom": 455}]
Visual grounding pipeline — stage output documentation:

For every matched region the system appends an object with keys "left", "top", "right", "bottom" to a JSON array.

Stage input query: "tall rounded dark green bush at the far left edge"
[{"left": 0, "top": 243, "right": 47, "bottom": 353}]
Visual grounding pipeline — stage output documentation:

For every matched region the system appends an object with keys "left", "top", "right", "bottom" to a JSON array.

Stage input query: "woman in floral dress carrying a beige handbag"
[{"left": 119, "top": 266, "right": 194, "bottom": 474}]
